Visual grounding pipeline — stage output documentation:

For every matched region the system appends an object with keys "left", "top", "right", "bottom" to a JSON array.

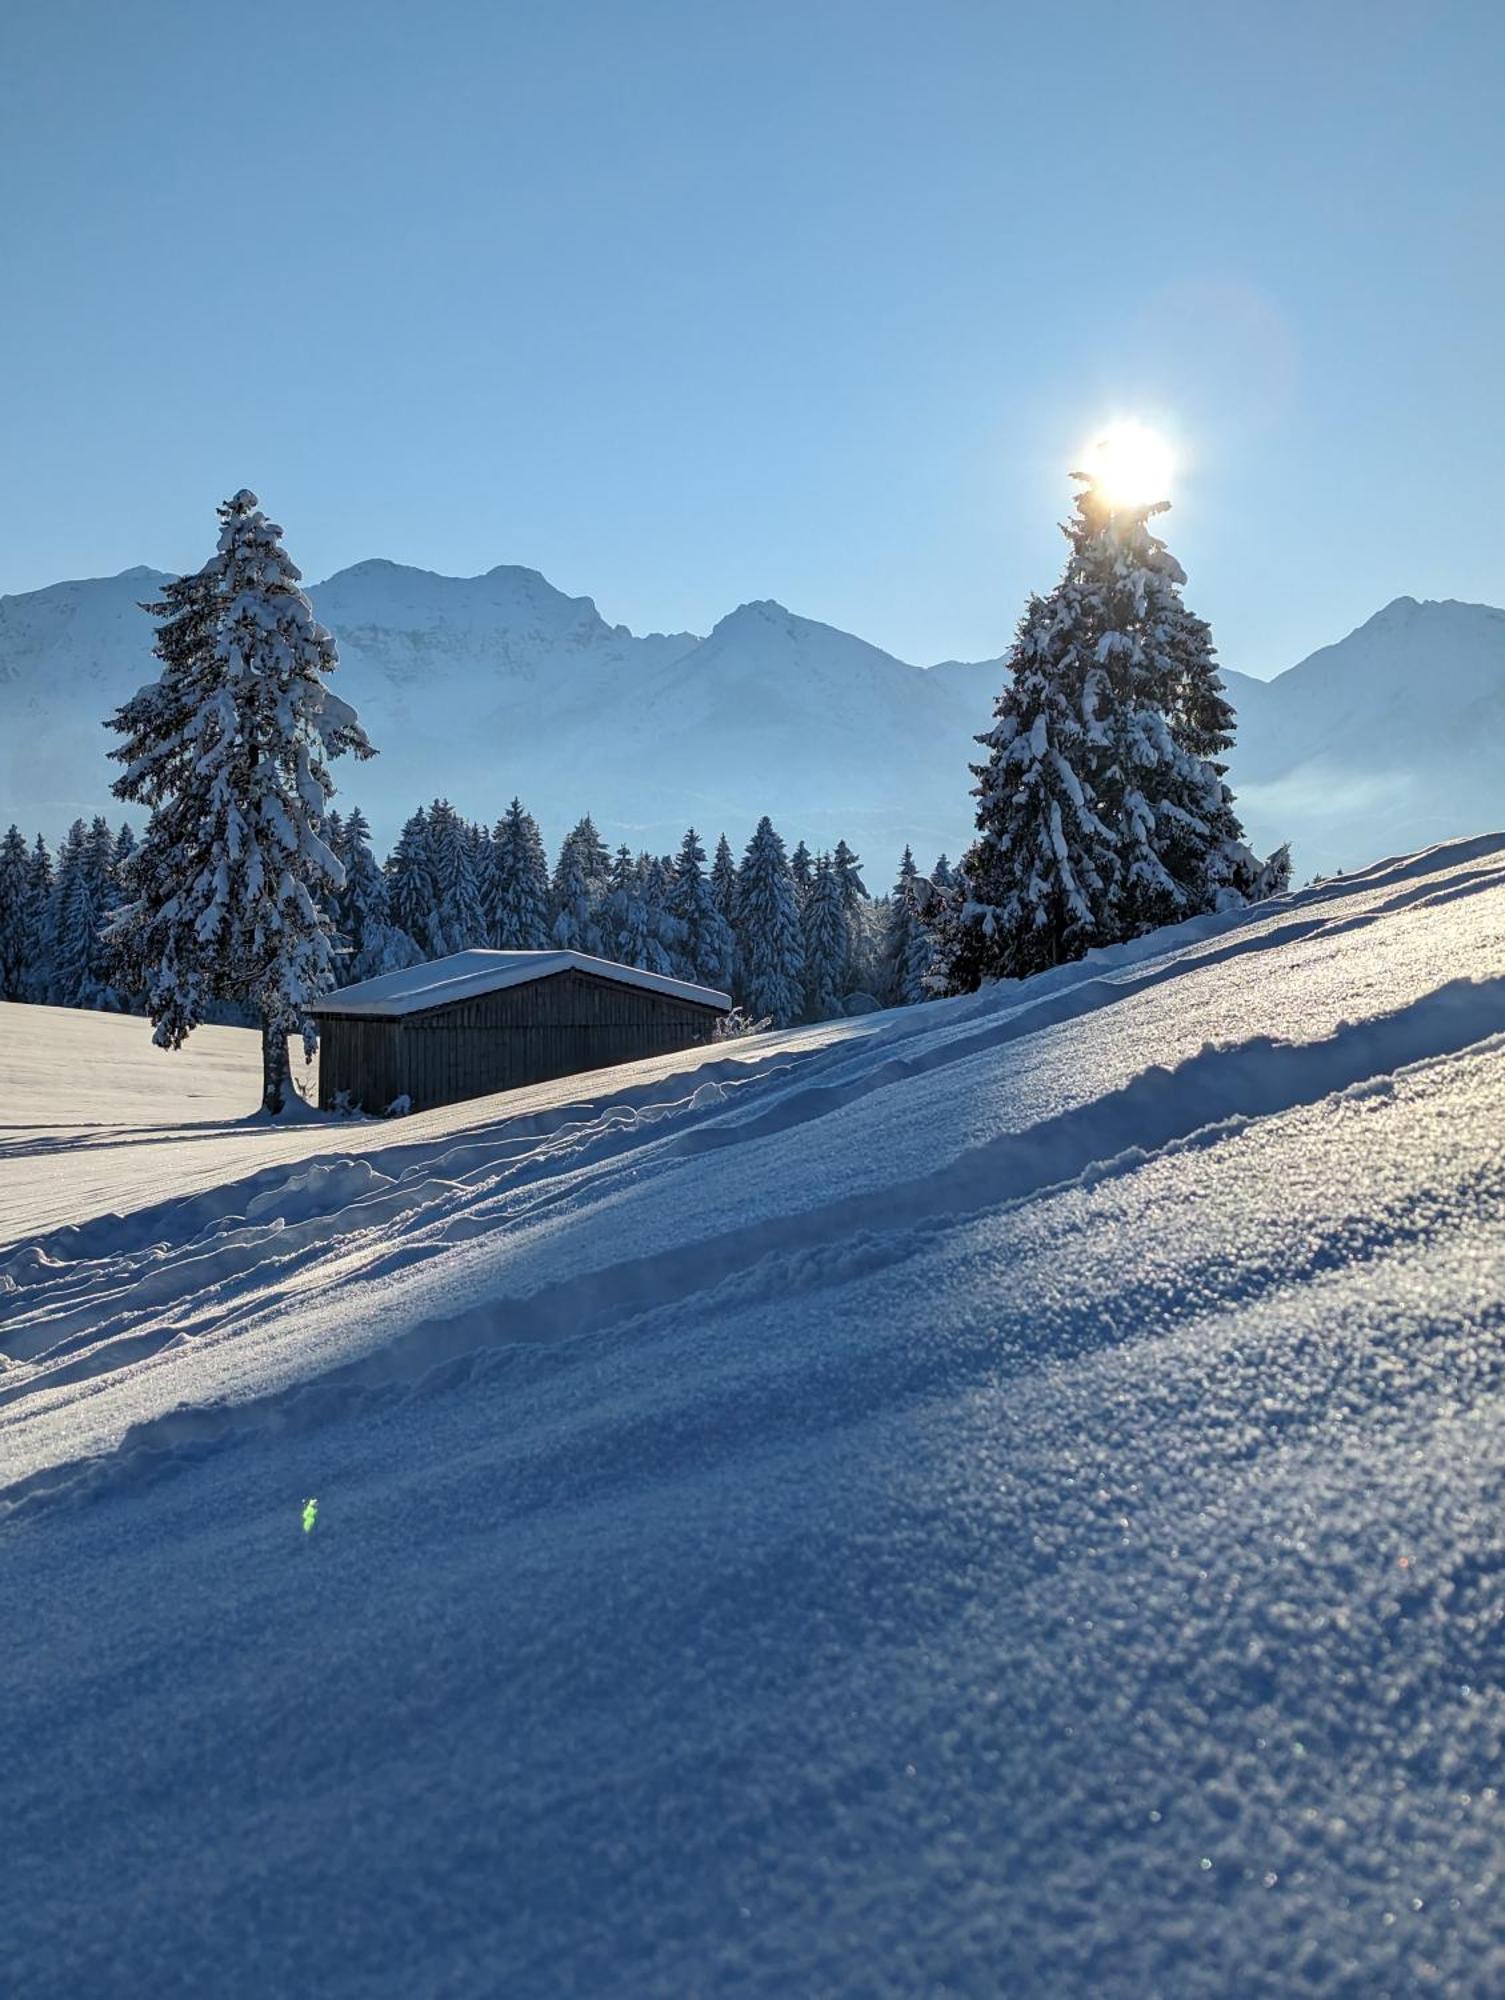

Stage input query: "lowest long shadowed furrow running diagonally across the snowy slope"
[{"left": 11, "top": 978, "right": 1505, "bottom": 1514}]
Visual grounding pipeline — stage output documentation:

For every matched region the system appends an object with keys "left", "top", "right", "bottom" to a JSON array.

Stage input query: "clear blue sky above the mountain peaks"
[{"left": 0, "top": 0, "right": 1505, "bottom": 674}]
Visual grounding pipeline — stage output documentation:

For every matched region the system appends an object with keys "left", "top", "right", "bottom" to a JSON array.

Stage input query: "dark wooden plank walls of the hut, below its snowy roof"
[{"left": 318, "top": 972, "right": 718, "bottom": 1112}]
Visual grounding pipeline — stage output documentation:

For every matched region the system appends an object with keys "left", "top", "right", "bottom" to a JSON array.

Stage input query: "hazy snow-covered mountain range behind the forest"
[{"left": 0, "top": 562, "right": 1505, "bottom": 884}]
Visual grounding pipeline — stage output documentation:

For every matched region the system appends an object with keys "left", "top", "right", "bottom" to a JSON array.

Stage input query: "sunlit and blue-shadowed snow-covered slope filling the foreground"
[{"left": 0, "top": 836, "right": 1505, "bottom": 2000}]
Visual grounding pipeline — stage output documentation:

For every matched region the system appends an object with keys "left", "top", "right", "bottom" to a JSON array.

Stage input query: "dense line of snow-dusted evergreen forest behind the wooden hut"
[{"left": 0, "top": 798, "right": 953, "bottom": 1026}]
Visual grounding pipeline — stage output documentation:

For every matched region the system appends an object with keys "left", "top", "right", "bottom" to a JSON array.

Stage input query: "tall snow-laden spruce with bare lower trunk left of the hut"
[{"left": 116, "top": 490, "right": 372, "bottom": 1116}]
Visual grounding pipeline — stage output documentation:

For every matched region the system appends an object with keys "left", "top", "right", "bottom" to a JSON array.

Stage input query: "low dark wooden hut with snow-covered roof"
[{"left": 310, "top": 952, "right": 732, "bottom": 1112}]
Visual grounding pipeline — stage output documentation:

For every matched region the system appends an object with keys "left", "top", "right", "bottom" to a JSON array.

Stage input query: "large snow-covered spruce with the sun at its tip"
[{"left": 939, "top": 474, "right": 1288, "bottom": 990}]
